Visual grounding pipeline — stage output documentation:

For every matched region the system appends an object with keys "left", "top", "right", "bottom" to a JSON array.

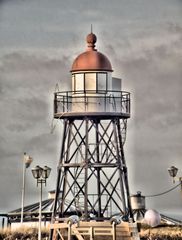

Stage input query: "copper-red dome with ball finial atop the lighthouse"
[{"left": 71, "top": 33, "right": 113, "bottom": 72}]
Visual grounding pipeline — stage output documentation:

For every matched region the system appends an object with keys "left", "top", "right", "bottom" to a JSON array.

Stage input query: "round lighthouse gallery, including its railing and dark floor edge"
[{"left": 54, "top": 90, "right": 130, "bottom": 119}]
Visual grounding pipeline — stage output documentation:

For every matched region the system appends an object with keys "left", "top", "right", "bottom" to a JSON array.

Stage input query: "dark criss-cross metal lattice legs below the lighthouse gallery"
[{"left": 53, "top": 117, "right": 130, "bottom": 219}]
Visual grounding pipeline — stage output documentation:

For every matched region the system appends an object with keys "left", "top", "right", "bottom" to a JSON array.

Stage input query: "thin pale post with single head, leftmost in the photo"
[{"left": 21, "top": 153, "right": 33, "bottom": 224}]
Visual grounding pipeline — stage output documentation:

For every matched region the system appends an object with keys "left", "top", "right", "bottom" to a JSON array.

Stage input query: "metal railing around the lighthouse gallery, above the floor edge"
[{"left": 54, "top": 90, "right": 130, "bottom": 115}]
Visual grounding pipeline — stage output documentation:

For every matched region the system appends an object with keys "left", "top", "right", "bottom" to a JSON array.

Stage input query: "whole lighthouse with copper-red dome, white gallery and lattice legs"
[{"left": 50, "top": 32, "right": 138, "bottom": 239}]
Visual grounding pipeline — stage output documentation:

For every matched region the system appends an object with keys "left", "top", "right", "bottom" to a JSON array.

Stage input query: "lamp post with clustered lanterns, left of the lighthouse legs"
[{"left": 32, "top": 166, "right": 51, "bottom": 240}]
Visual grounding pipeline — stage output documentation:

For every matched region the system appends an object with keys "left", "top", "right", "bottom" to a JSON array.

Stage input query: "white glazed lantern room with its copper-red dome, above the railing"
[{"left": 71, "top": 32, "right": 121, "bottom": 93}]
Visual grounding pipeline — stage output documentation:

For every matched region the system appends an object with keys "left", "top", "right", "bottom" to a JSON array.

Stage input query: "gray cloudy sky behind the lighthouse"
[{"left": 0, "top": 0, "right": 182, "bottom": 218}]
